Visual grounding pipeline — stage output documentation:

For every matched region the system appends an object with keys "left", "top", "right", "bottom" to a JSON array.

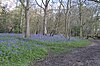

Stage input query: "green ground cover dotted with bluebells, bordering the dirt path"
[{"left": 0, "top": 37, "right": 90, "bottom": 66}]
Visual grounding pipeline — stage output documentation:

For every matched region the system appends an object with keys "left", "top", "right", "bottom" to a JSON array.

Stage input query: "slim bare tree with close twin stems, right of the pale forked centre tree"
[{"left": 59, "top": 0, "right": 71, "bottom": 37}]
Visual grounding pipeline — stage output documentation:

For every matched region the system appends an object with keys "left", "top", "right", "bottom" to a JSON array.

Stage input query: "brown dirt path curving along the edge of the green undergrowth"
[{"left": 35, "top": 40, "right": 100, "bottom": 66}]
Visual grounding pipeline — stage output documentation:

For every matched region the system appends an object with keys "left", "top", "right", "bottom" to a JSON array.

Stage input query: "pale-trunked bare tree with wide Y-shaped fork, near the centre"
[{"left": 35, "top": 0, "right": 50, "bottom": 35}]
